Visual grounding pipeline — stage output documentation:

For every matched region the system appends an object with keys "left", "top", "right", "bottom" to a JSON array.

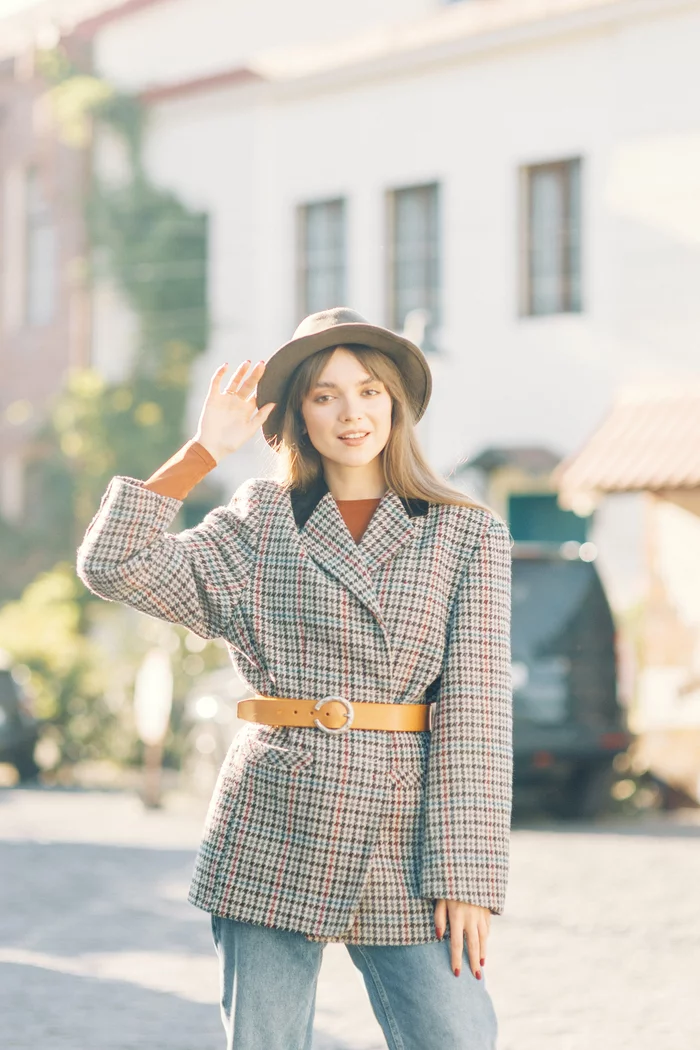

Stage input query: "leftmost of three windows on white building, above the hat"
[{"left": 297, "top": 200, "right": 345, "bottom": 317}]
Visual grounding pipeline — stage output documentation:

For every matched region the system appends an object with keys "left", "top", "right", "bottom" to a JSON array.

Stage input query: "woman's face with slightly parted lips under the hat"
[{"left": 301, "top": 347, "right": 391, "bottom": 466}]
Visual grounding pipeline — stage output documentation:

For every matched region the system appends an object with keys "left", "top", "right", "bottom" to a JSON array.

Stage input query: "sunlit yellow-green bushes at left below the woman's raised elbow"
[{"left": 0, "top": 563, "right": 225, "bottom": 765}]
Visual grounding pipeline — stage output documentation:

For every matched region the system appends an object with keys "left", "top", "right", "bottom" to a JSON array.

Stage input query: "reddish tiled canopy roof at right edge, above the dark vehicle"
[{"left": 552, "top": 378, "right": 700, "bottom": 503}]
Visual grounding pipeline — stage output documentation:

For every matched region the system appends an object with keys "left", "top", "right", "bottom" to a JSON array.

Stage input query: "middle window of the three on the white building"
[{"left": 388, "top": 183, "right": 441, "bottom": 350}]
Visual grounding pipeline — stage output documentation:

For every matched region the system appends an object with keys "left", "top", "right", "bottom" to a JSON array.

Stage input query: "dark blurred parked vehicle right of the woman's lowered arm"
[{"left": 511, "top": 543, "right": 634, "bottom": 818}]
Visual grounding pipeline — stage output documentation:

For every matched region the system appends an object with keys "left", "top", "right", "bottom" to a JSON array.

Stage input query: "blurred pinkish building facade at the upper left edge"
[{"left": 0, "top": 48, "right": 90, "bottom": 527}]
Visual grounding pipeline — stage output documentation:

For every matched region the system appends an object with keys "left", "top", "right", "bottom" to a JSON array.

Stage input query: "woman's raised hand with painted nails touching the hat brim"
[{"left": 195, "top": 361, "right": 275, "bottom": 463}]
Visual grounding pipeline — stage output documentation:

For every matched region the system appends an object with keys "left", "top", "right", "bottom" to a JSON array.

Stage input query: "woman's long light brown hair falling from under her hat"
[{"left": 270, "top": 343, "right": 500, "bottom": 518}]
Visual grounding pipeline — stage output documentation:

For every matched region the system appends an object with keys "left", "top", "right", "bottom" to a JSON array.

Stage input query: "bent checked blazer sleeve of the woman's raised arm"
[{"left": 78, "top": 477, "right": 260, "bottom": 638}]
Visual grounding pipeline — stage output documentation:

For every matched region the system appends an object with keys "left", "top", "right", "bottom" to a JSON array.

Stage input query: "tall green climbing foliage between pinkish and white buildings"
[{"left": 8, "top": 47, "right": 209, "bottom": 569}]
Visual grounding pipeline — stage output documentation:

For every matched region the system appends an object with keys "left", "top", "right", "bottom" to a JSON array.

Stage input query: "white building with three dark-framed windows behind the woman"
[{"left": 76, "top": 0, "right": 700, "bottom": 497}]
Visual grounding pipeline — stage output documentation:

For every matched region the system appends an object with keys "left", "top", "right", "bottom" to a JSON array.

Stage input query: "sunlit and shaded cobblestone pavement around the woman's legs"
[{"left": 0, "top": 790, "right": 700, "bottom": 1050}]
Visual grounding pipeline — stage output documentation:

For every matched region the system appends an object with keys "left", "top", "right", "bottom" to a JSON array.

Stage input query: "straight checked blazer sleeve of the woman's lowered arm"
[{"left": 421, "top": 518, "right": 513, "bottom": 915}]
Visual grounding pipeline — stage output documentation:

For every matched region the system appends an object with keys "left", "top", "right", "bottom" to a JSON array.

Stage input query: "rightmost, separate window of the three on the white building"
[{"left": 521, "top": 160, "right": 581, "bottom": 315}]
